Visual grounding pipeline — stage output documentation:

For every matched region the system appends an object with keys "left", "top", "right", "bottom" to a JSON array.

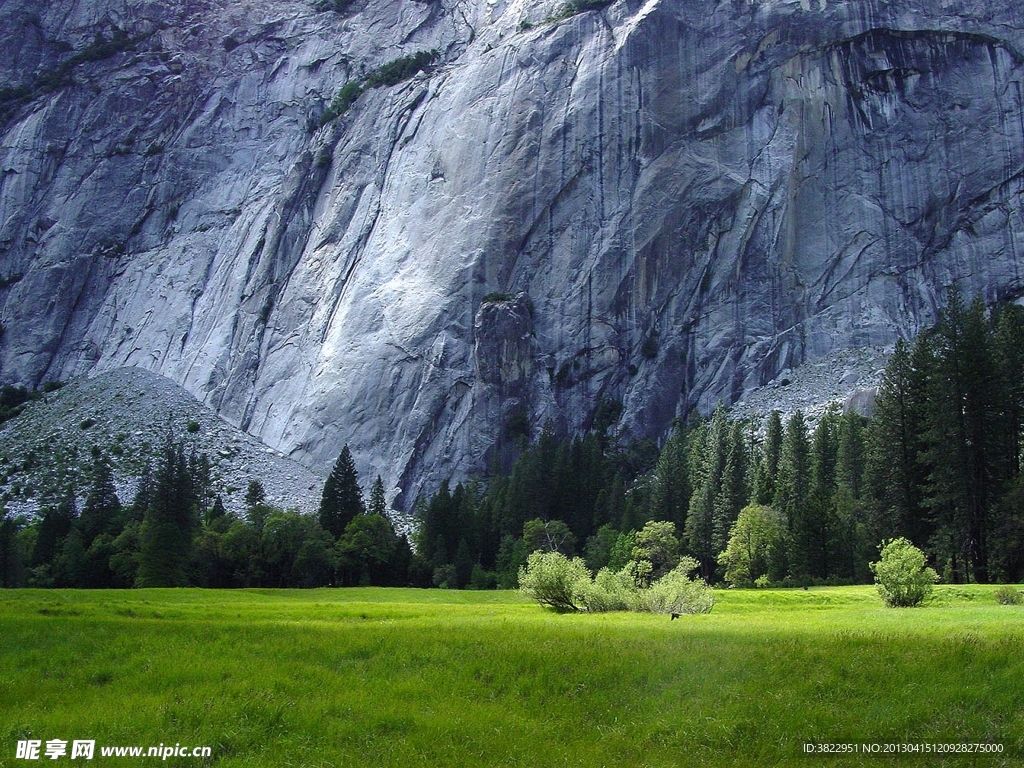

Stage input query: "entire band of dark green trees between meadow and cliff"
[{"left": 6, "top": 290, "right": 1024, "bottom": 589}]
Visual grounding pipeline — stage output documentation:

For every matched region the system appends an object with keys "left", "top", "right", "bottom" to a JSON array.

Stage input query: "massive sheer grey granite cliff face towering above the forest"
[{"left": 0, "top": 0, "right": 1024, "bottom": 508}]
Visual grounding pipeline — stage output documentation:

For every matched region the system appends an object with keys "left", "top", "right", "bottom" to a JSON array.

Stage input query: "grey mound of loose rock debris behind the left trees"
[{"left": 0, "top": 369, "right": 324, "bottom": 515}]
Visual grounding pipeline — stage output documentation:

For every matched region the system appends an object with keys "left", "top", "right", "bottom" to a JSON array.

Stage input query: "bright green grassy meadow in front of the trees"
[{"left": 0, "top": 586, "right": 1024, "bottom": 768}]
